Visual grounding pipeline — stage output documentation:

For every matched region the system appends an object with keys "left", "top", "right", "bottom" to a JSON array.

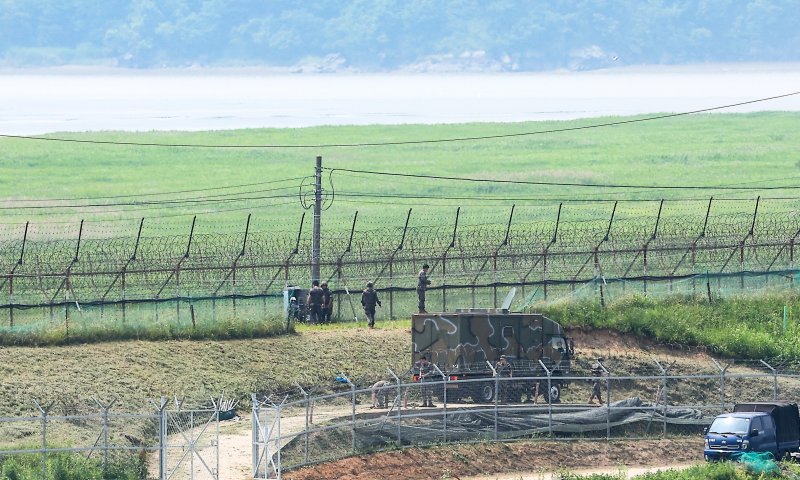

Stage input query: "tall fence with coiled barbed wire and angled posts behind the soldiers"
[{"left": 0, "top": 198, "right": 800, "bottom": 329}]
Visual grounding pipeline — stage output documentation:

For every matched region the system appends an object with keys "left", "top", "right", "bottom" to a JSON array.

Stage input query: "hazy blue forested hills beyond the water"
[{"left": 0, "top": 0, "right": 800, "bottom": 72}]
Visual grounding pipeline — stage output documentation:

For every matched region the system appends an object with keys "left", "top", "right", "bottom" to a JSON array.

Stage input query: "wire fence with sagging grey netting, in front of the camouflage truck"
[{"left": 251, "top": 358, "right": 800, "bottom": 479}]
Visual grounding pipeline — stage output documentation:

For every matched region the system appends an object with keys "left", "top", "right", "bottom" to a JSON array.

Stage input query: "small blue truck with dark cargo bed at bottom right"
[{"left": 703, "top": 402, "right": 800, "bottom": 461}]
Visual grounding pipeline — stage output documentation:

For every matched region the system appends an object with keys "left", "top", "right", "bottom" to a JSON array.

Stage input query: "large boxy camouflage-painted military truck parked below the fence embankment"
[{"left": 411, "top": 309, "right": 574, "bottom": 402}]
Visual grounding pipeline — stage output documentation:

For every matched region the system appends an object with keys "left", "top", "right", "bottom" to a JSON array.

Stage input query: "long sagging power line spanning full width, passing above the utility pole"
[{"left": 0, "top": 91, "right": 800, "bottom": 149}]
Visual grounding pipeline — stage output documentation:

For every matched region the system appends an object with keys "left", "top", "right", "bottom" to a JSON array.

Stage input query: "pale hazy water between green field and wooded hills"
[{"left": 0, "top": 64, "right": 800, "bottom": 135}]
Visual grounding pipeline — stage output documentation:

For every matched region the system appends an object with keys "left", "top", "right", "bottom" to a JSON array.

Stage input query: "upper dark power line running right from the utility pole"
[{"left": 329, "top": 168, "right": 800, "bottom": 191}]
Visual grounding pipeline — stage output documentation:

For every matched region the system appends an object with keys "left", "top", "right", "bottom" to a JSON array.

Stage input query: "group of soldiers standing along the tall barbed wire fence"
[{"left": 306, "top": 263, "right": 431, "bottom": 328}]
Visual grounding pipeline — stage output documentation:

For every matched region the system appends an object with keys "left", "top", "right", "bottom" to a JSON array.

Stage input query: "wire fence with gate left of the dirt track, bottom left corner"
[{"left": 0, "top": 397, "right": 219, "bottom": 480}]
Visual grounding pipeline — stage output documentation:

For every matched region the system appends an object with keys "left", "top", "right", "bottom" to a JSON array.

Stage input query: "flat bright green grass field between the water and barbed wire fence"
[{"left": 0, "top": 113, "right": 800, "bottom": 239}]
